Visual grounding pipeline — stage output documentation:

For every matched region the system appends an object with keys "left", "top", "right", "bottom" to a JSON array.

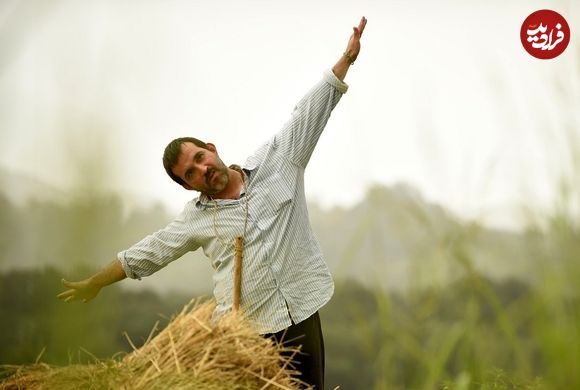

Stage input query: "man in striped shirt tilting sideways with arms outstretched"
[{"left": 58, "top": 17, "right": 366, "bottom": 389}]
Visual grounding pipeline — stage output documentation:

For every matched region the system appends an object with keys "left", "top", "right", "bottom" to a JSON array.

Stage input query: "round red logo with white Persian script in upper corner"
[{"left": 520, "top": 9, "right": 570, "bottom": 60}]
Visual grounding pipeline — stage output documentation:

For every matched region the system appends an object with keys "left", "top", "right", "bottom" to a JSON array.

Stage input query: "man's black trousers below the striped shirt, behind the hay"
[{"left": 264, "top": 312, "right": 324, "bottom": 390}]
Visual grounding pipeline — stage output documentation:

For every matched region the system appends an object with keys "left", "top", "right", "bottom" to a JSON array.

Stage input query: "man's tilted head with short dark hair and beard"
[{"left": 163, "top": 137, "right": 229, "bottom": 196}]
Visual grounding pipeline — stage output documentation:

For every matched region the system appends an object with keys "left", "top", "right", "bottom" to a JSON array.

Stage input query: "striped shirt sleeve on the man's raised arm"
[{"left": 273, "top": 70, "right": 348, "bottom": 168}]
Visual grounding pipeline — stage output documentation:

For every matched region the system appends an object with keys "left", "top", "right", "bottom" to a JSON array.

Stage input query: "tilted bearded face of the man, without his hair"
[{"left": 171, "top": 142, "right": 229, "bottom": 196}]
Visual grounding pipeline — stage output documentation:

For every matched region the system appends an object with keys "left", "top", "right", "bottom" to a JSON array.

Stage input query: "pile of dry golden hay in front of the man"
[{"left": 0, "top": 303, "right": 308, "bottom": 390}]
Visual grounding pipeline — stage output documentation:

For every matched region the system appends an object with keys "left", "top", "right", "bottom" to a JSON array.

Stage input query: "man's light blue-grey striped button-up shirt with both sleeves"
[{"left": 118, "top": 70, "right": 348, "bottom": 333}]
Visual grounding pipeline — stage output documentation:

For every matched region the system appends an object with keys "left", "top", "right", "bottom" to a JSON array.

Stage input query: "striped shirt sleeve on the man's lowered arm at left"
[{"left": 117, "top": 207, "right": 199, "bottom": 279}]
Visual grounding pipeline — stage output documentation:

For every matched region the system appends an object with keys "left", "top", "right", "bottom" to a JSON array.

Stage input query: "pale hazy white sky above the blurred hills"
[{"left": 0, "top": 0, "right": 580, "bottom": 228}]
